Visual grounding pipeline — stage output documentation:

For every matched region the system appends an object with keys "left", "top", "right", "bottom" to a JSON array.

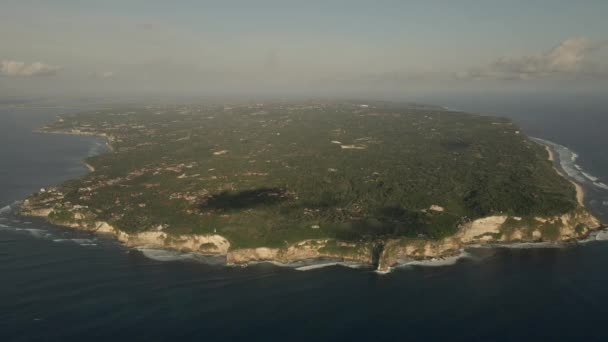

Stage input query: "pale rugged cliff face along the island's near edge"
[{"left": 22, "top": 203, "right": 601, "bottom": 271}]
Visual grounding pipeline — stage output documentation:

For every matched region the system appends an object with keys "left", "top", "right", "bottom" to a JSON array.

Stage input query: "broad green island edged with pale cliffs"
[{"left": 20, "top": 101, "right": 602, "bottom": 271}]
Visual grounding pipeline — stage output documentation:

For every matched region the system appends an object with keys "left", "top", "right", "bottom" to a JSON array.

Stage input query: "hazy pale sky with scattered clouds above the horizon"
[{"left": 0, "top": 0, "right": 608, "bottom": 95}]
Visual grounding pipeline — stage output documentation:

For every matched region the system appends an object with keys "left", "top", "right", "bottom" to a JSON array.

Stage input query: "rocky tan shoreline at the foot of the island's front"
[{"left": 17, "top": 201, "right": 608, "bottom": 274}]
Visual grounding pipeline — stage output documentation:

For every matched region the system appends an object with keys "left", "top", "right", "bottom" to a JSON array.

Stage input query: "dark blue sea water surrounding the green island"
[{"left": 0, "top": 97, "right": 608, "bottom": 341}]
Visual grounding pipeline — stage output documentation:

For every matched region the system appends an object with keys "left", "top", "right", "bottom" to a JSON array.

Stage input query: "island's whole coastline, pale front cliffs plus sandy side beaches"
[{"left": 19, "top": 130, "right": 605, "bottom": 272}]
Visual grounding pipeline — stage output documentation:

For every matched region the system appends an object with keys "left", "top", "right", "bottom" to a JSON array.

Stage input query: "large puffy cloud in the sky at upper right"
[{"left": 464, "top": 38, "right": 605, "bottom": 80}]
